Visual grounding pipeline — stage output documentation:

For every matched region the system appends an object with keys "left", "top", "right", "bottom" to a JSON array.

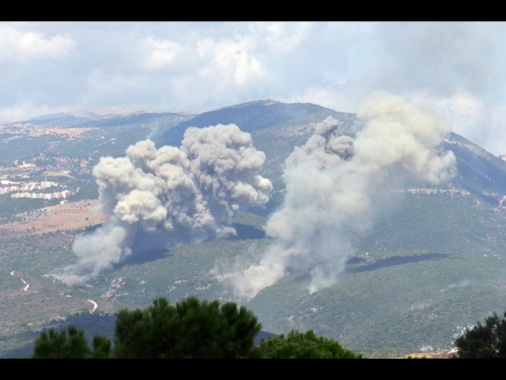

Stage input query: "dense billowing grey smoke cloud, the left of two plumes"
[{"left": 56, "top": 124, "right": 272, "bottom": 284}]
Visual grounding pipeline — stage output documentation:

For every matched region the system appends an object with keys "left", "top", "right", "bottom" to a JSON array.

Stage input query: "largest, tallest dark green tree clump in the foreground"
[{"left": 114, "top": 297, "right": 261, "bottom": 359}]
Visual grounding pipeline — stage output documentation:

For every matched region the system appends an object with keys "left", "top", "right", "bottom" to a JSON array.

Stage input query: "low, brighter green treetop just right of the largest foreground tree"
[{"left": 258, "top": 330, "right": 362, "bottom": 359}]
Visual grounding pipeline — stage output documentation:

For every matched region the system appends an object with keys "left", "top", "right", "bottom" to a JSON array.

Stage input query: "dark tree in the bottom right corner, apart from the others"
[{"left": 454, "top": 312, "right": 506, "bottom": 359}]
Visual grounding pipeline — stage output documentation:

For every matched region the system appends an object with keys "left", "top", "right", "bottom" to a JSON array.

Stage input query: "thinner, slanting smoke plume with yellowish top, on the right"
[{"left": 219, "top": 93, "right": 455, "bottom": 298}]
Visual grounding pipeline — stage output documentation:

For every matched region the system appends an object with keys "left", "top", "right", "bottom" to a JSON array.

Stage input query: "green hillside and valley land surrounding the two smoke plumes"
[{"left": 0, "top": 100, "right": 506, "bottom": 357}]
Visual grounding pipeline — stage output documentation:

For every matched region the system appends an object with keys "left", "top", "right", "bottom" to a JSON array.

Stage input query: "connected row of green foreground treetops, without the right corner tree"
[{"left": 33, "top": 297, "right": 362, "bottom": 359}]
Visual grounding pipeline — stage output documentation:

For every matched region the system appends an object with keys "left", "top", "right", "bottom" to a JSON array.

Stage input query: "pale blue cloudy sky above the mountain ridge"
[{"left": 0, "top": 21, "right": 506, "bottom": 155}]
